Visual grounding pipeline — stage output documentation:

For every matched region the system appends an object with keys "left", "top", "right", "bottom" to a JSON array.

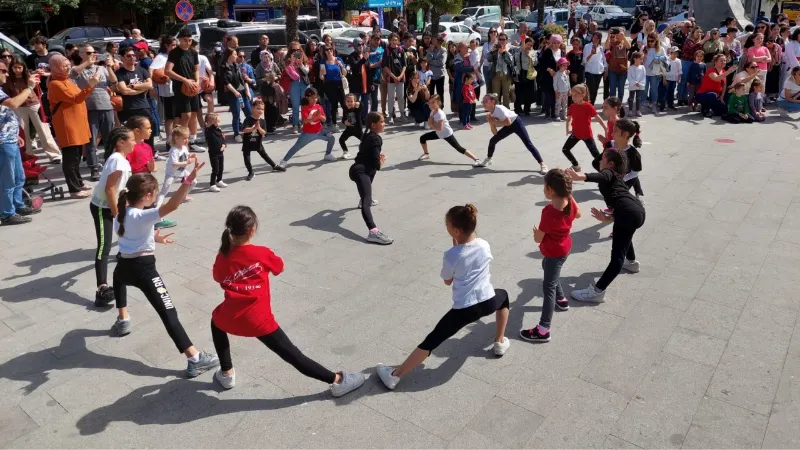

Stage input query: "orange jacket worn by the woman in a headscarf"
[{"left": 47, "top": 80, "right": 94, "bottom": 148}]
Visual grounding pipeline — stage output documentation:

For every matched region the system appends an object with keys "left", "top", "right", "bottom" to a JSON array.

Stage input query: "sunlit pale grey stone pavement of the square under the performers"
[{"left": 0, "top": 103, "right": 800, "bottom": 450}]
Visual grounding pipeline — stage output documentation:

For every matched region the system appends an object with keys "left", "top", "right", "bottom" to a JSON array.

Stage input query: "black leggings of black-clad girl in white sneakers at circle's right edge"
[{"left": 595, "top": 206, "right": 644, "bottom": 291}]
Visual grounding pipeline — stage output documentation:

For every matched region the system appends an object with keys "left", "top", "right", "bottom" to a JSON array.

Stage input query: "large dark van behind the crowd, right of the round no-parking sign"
[{"left": 200, "top": 23, "right": 311, "bottom": 58}]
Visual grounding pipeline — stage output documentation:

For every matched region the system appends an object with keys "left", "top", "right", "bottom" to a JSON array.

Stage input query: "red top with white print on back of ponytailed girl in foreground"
[{"left": 211, "top": 245, "right": 283, "bottom": 337}]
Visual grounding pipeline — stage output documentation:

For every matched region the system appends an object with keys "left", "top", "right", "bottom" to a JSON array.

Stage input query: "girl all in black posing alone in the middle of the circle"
[{"left": 350, "top": 112, "right": 394, "bottom": 245}]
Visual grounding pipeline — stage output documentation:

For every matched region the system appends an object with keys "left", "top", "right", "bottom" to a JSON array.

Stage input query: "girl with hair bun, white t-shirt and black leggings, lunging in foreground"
[{"left": 376, "top": 204, "right": 511, "bottom": 389}]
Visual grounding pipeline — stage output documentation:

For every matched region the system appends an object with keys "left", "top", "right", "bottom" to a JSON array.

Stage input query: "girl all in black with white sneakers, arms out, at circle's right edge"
[{"left": 567, "top": 146, "right": 645, "bottom": 303}]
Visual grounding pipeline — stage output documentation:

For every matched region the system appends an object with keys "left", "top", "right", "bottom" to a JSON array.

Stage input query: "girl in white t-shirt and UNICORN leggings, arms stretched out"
[{"left": 114, "top": 163, "right": 219, "bottom": 378}]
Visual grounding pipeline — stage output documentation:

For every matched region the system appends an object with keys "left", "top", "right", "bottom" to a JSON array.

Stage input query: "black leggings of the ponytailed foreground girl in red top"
[{"left": 211, "top": 320, "right": 336, "bottom": 384}]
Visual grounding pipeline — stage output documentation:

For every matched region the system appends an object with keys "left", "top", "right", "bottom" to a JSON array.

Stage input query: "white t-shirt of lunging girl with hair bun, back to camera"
[{"left": 441, "top": 238, "right": 494, "bottom": 309}]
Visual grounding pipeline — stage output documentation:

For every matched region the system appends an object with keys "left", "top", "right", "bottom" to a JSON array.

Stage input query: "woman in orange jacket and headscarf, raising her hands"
[{"left": 47, "top": 55, "right": 100, "bottom": 198}]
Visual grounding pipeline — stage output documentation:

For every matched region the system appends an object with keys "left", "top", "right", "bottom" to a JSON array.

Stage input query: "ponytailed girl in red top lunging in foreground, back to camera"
[{"left": 211, "top": 206, "right": 364, "bottom": 397}]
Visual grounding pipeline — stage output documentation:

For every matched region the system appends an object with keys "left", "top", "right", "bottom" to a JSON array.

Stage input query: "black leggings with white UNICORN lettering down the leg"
[{"left": 114, "top": 255, "right": 192, "bottom": 353}]
